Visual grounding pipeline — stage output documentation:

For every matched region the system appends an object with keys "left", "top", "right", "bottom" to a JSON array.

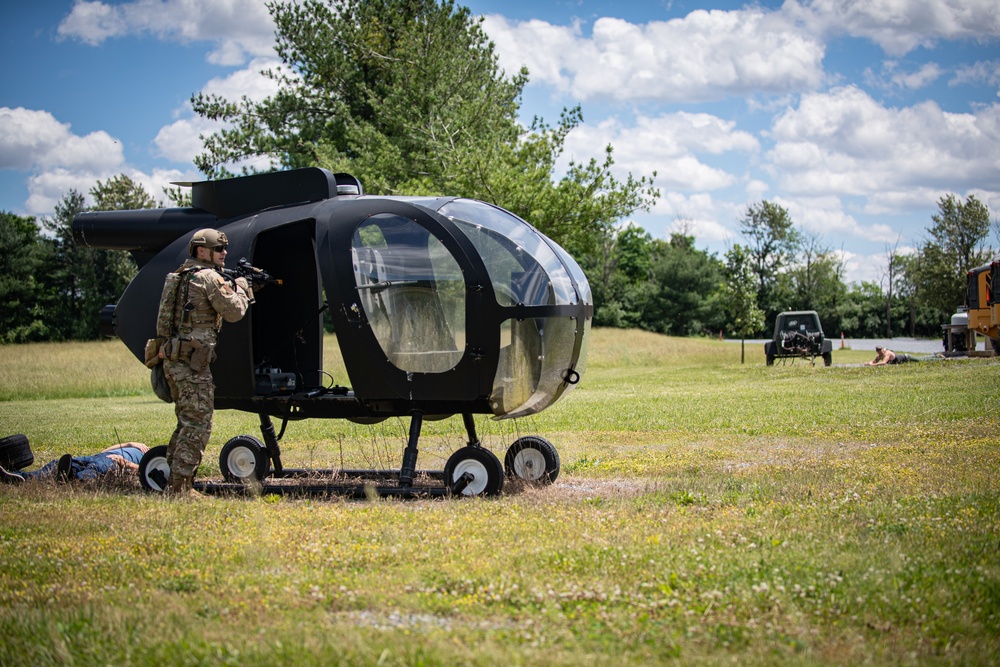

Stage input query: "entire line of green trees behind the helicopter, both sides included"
[{"left": 0, "top": 0, "right": 989, "bottom": 342}]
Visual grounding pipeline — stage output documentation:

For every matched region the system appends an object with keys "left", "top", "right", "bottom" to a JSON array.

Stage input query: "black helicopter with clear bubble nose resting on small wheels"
[{"left": 73, "top": 168, "right": 593, "bottom": 496}]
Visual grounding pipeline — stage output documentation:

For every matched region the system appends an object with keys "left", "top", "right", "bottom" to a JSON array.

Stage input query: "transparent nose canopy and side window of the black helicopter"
[{"left": 351, "top": 198, "right": 593, "bottom": 418}]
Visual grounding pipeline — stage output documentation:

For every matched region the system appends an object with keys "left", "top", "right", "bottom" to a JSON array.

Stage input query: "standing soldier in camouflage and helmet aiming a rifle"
[{"left": 156, "top": 229, "right": 254, "bottom": 496}]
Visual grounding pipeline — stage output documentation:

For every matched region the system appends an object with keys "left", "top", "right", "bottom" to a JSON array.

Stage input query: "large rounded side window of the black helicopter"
[{"left": 351, "top": 214, "right": 466, "bottom": 373}]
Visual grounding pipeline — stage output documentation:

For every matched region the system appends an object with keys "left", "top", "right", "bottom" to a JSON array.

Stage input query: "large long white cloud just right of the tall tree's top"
[{"left": 484, "top": 9, "right": 824, "bottom": 101}]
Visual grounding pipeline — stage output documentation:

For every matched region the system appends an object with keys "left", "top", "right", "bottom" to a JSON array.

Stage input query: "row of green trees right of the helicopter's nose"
[{"left": 581, "top": 194, "right": 1000, "bottom": 338}]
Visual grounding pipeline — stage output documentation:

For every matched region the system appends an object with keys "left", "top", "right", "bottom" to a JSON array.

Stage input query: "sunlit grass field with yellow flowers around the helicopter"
[{"left": 0, "top": 330, "right": 1000, "bottom": 666}]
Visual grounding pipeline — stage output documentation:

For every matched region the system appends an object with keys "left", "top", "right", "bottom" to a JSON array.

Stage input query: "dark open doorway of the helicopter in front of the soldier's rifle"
[{"left": 249, "top": 220, "right": 323, "bottom": 395}]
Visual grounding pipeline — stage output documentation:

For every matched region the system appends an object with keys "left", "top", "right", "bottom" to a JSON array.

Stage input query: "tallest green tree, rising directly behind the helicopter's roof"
[{"left": 192, "top": 0, "right": 658, "bottom": 252}]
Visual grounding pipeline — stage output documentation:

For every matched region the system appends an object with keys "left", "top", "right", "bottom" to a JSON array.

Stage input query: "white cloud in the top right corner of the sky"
[{"left": 780, "top": 0, "right": 1000, "bottom": 56}]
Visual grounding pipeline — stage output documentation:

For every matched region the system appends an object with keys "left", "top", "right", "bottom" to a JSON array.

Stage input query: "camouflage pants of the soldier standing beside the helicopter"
[{"left": 163, "top": 361, "right": 215, "bottom": 477}]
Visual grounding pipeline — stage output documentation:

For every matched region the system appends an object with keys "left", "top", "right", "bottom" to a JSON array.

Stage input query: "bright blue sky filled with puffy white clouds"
[{"left": 0, "top": 0, "right": 1000, "bottom": 281}]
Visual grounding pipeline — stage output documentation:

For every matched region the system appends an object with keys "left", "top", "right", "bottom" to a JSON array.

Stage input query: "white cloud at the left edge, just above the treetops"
[{"left": 0, "top": 107, "right": 125, "bottom": 172}]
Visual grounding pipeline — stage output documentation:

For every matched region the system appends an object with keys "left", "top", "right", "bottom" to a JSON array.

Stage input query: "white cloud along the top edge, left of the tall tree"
[{"left": 58, "top": 0, "right": 274, "bottom": 65}]
